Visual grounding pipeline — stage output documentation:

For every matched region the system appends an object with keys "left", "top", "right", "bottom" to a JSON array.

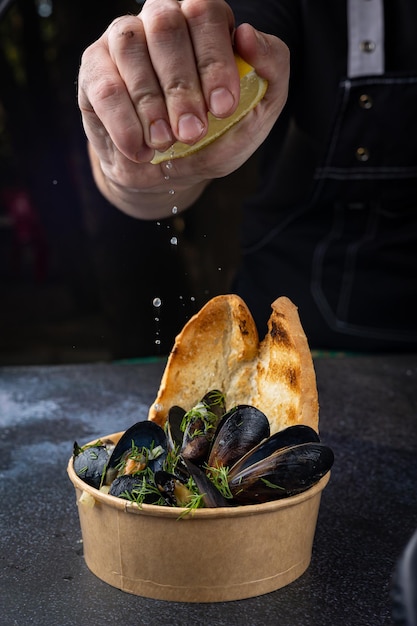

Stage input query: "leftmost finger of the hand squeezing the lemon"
[{"left": 78, "top": 31, "right": 153, "bottom": 162}]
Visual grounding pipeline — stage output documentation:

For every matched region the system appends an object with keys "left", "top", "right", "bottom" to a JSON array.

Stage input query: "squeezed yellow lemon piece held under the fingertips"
[{"left": 151, "top": 55, "right": 268, "bottom": 165}]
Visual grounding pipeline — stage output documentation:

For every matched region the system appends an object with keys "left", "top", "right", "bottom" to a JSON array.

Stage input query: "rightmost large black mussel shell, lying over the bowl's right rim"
[{"left": 229, "top": 442, "right": 334, "bottom": 504}]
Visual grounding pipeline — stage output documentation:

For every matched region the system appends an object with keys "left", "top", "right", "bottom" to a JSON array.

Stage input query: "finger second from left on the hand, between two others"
[{"left": 107, "top": 16, "right": 174, "bottom": 150}]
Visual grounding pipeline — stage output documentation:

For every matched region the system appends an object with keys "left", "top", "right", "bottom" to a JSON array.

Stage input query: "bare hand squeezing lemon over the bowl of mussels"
[{"left": 79, "top": 0, "right": 289, "bottom": 218}]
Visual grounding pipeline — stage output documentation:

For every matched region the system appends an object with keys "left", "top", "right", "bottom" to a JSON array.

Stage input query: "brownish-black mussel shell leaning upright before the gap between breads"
[{"left": 207, "top": 404, "right": 270, "bottom": 467}]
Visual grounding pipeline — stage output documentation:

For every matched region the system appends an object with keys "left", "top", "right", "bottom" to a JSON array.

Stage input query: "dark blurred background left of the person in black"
[{"left": 0, "top": 0, "right": 253, "bottom": 365}]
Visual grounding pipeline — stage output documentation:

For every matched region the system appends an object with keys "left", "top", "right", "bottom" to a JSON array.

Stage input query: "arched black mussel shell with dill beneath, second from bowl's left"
[{"left": 108, "top": 420, "right": 167, "bottom": 471}]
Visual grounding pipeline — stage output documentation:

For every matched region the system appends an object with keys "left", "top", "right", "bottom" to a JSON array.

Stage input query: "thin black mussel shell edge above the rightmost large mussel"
[{"left": 230, "top": 424, "right": 320, "bottom": 476}]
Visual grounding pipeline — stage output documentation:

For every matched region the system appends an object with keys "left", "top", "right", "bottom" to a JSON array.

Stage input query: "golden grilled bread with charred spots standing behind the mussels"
[{"left": 148, "top": 294, "right": 318, "bottom": 433}]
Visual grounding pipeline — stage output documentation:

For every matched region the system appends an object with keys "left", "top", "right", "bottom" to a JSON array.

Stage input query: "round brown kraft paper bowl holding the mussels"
[{"left": 68, "top": 433, "right": 330, "bottom": 602}]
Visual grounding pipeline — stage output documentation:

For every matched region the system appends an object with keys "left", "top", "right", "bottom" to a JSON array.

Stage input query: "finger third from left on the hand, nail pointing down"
[{"left": 139, "top": 0, "right": 207, "bottom": 143}]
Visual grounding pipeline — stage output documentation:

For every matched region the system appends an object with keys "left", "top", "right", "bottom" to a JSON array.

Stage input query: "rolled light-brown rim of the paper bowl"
[{"left": 67, "top": 431, "right": 331, "bottom": 521}]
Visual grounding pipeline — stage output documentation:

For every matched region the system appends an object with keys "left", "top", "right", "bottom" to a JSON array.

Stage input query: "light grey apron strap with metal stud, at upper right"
[{"left": 347, "top": 0, "right": 385, "bottom": 78}]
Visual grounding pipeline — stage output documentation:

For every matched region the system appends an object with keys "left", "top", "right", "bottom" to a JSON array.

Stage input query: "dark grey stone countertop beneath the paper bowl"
[{"left": 0, "top": 355, "right": 417, "bottom": 626}]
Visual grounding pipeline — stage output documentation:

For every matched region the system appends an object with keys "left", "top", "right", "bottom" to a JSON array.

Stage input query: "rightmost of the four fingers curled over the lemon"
[{"left": 181, "top": 0, "right": 239, "bottom": 117}]
